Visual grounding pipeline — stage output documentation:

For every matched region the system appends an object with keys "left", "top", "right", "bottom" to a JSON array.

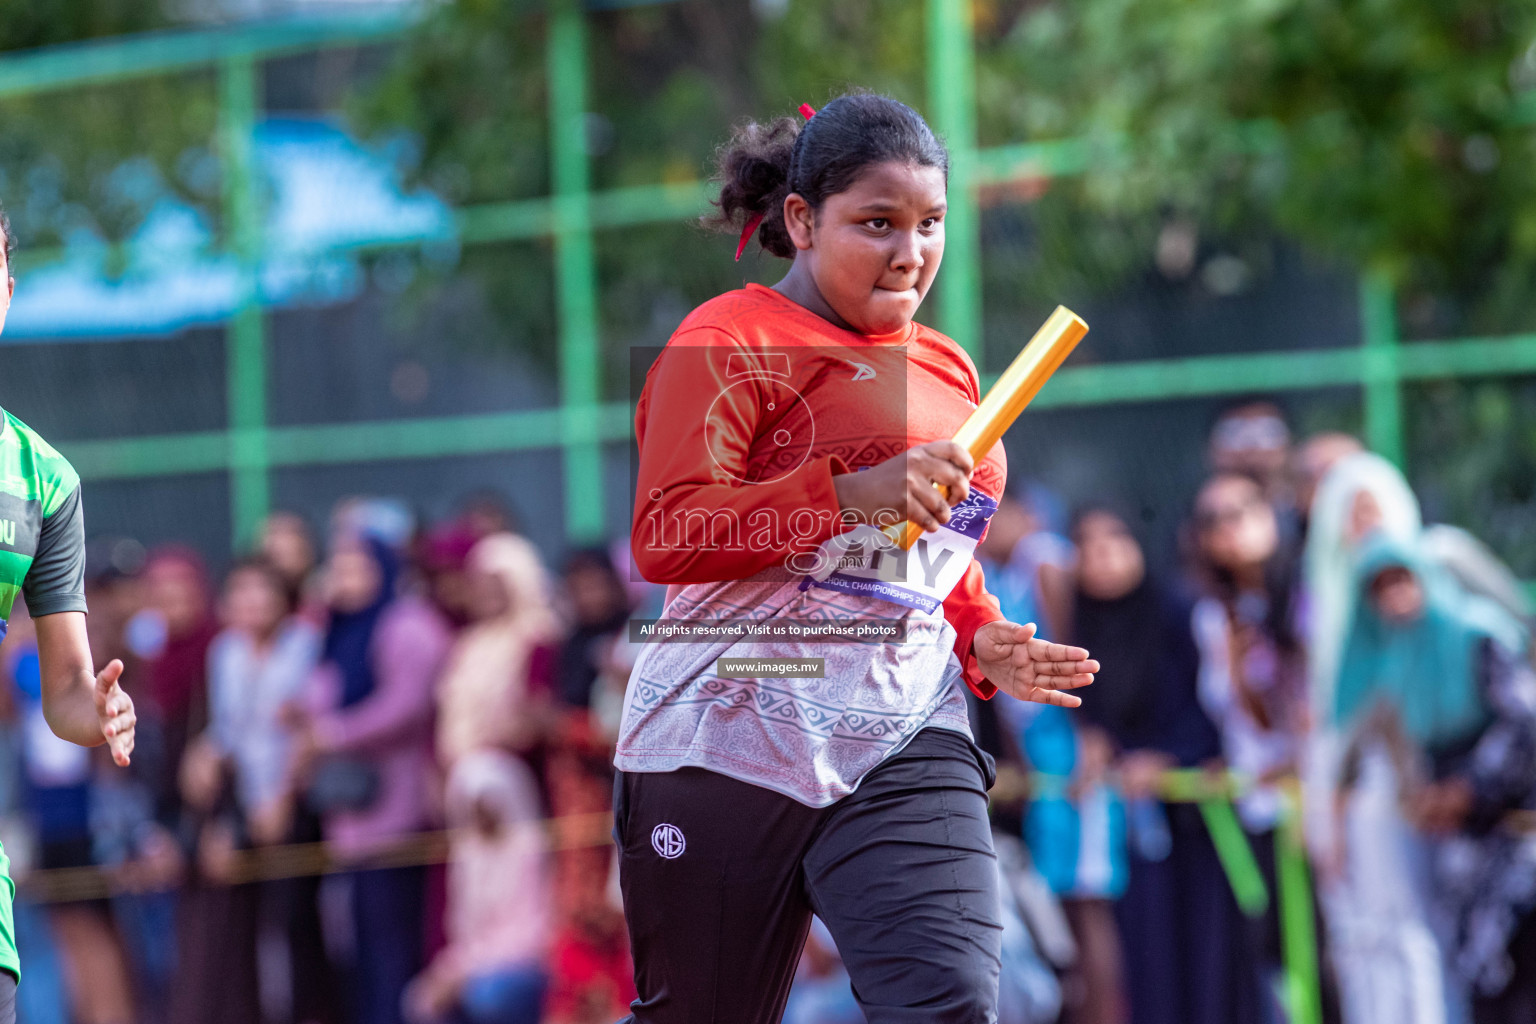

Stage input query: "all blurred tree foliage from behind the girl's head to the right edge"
[{"left": 358, "top": 0, "right": 1536, "bottom": 356}]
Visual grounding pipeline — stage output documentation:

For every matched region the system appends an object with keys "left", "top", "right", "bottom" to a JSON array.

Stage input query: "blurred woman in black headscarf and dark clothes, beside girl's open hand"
[{"left": 1071, "top": 508, "right": 1253, "bottom": 1024}]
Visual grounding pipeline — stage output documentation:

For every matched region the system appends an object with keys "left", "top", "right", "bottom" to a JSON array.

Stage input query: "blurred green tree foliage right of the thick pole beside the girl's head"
[{"left": 991, "top": 0, "right": 1536, "bottom": 333}]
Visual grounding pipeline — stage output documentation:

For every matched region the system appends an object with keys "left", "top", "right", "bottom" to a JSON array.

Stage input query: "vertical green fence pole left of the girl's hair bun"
[{"left": 547, "top": 0, "right": 605, "bottom": 542}]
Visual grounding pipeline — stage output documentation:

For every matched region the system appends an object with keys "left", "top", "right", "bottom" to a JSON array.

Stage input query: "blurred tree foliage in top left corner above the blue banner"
[{"left": 0, "top": 0, "right": 221, "bottom": 269}]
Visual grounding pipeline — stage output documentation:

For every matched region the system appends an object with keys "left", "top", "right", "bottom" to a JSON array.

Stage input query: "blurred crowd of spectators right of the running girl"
[{"left": 946, "top": 401, "right": 1536, "bottom": 1024}]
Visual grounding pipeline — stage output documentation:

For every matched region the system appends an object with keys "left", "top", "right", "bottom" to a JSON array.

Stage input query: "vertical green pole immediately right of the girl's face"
[{"left": 928, "top": 0, "right": 985, "bottom": 368}]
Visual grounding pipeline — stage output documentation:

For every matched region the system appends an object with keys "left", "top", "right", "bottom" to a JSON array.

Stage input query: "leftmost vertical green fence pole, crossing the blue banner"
[{"left": 218, "top": 55, "right": 270, "bottom": 551}]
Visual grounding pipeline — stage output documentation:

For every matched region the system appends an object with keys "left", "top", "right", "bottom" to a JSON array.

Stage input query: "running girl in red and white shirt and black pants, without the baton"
[{"left": 614, "top": 95, "right": 1098, "bottom": 1024}]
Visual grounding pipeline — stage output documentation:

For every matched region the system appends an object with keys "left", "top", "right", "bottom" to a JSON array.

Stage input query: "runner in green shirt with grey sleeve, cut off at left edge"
[{"left": 0, "top": 202, "right": 135, "bottom": 1024}]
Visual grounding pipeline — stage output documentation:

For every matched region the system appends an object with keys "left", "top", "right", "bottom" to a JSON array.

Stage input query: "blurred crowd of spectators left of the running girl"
[{"left": 0, "top": 496, "right": 662, "bottom": 1024}]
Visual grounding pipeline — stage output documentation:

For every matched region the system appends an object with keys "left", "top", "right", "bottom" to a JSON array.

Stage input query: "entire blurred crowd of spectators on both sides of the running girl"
[{"left": 0, "top": 401, "right": 1536, "bottom": 1024}]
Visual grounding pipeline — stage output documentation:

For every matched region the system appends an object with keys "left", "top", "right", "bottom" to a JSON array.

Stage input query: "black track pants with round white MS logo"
[{"left": 614, "top": 729, "right": 1001, "bottom": 1024}]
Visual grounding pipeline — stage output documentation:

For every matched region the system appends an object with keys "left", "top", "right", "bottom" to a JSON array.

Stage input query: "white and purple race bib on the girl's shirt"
[{"left": 800, "top": 488, "right": 997, "bottom": 614}]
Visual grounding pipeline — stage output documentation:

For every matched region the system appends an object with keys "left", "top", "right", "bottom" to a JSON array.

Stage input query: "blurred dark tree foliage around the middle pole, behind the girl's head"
[{"left": 355, "top": 0, "right": 926, "bottom": 388}]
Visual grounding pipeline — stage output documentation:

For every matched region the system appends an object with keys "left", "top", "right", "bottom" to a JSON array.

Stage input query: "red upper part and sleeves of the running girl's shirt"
[{"left": 631, "top": 284, "right": 1008, "bottom": 697}]
